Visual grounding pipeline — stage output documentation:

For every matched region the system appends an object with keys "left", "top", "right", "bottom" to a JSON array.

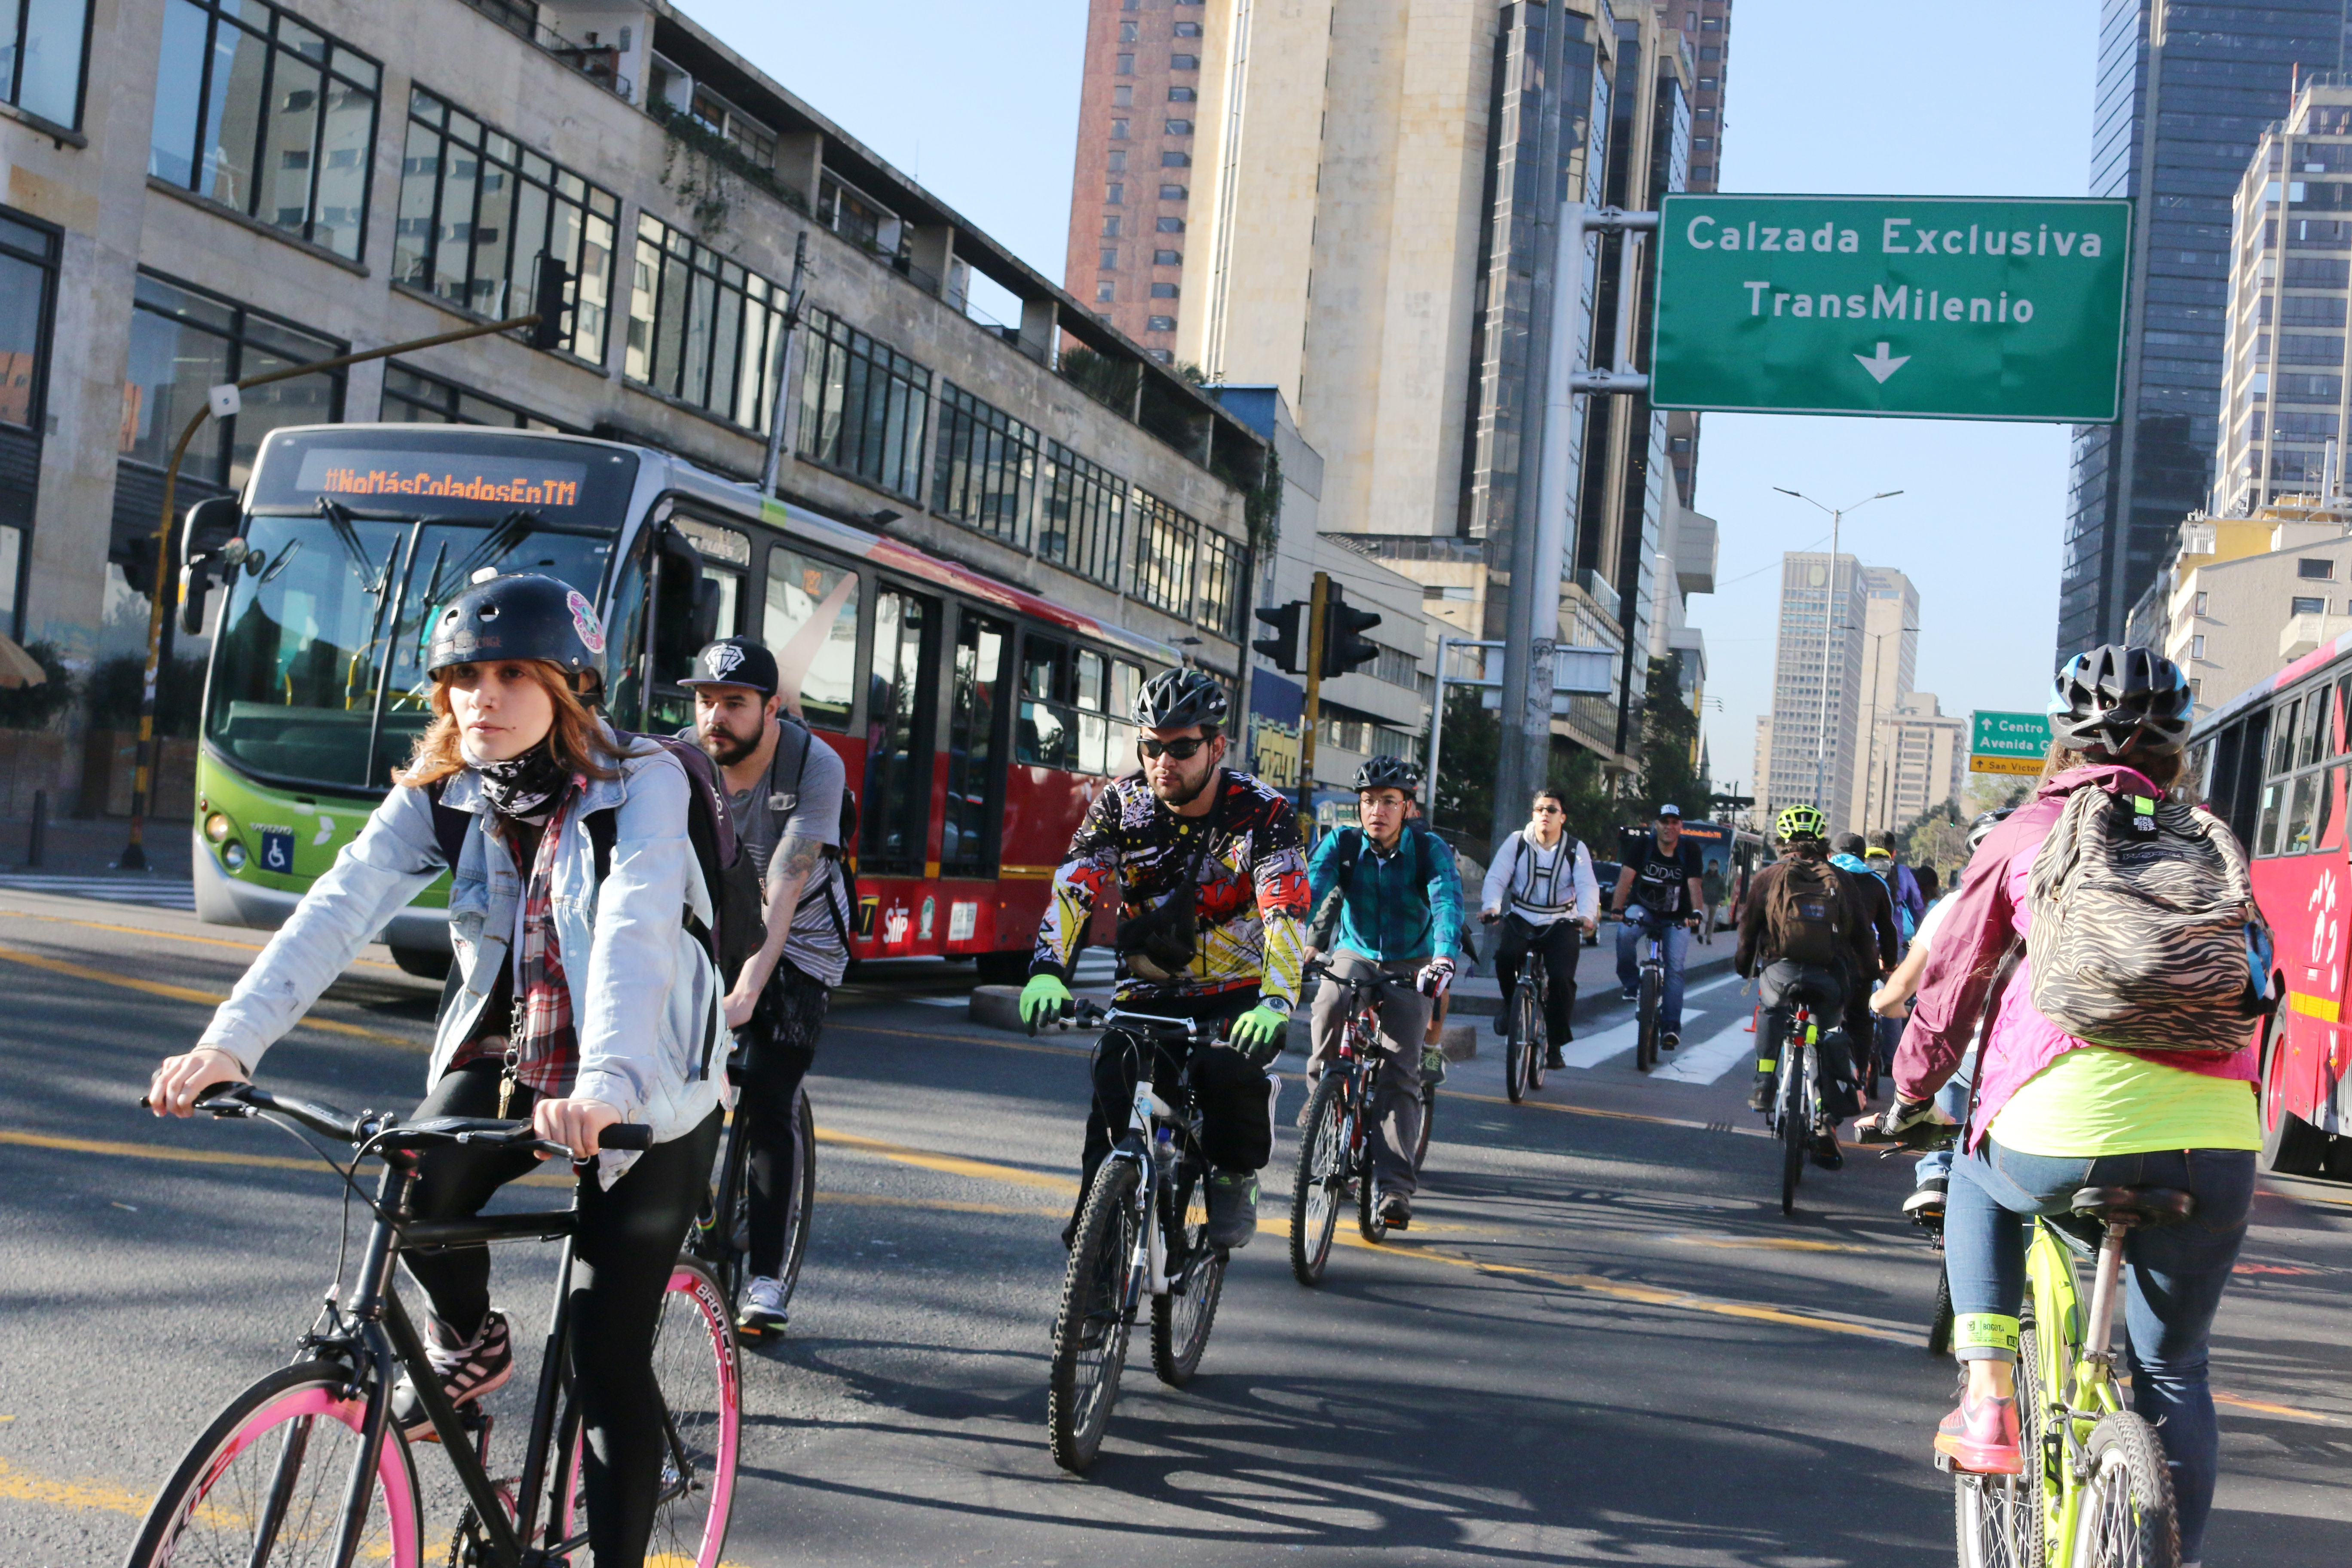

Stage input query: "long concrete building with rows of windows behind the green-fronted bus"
[{"left": 0, "top": 0, "right": 1373, "bottom": 738}]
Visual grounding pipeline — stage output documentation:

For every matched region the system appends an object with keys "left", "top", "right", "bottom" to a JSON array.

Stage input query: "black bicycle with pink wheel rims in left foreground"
[{"left": 129, "top": 1084, "right": 741, "bottom": 1568}]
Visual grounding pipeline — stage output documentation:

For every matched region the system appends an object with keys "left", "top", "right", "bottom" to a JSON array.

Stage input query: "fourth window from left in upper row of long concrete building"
[{"left": 621, "top": 211, "right": 786, "bottom": 430}]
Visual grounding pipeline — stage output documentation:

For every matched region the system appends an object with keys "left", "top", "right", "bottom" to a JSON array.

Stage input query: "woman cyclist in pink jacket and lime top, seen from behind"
[{"left": 1879, "top": 644, "right": 2260, "bottom": 1563}]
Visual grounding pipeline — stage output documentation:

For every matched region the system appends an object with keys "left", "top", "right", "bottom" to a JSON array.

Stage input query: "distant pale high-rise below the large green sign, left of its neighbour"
[{"left": 1755, "top": 550, "right": 1870, "bottom": 827}]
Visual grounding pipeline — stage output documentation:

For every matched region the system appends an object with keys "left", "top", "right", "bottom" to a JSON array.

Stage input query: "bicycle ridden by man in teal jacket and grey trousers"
[{"left": 1291, "top": 964, "right": 1428, "bottom": 1286}]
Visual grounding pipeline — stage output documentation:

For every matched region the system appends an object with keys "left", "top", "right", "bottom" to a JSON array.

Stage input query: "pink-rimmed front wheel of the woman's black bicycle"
[{"left": 125, "top": 1361, "right": 423, "bottom": 1568}]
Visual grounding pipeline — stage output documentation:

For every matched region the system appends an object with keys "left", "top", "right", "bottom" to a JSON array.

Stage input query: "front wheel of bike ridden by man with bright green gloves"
[{"left": 1044, "top": 1159, "right": 1141, "bottom": 1472}]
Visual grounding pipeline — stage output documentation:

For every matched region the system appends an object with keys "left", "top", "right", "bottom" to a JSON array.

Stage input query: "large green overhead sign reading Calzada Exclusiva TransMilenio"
[{"left": 1649, "top": 195, "right": 2131, "bottom": 423}]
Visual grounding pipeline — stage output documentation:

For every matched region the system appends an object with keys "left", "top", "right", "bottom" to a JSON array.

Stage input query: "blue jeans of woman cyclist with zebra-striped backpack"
[{"left": 1943, "top": 1138, "right": 2253, "bottom": 1563}]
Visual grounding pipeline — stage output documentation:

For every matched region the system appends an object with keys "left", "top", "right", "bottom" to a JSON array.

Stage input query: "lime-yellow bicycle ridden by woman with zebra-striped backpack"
[{"left": 1936, "top": 1187, "right": 2194, "bottom": 1568}]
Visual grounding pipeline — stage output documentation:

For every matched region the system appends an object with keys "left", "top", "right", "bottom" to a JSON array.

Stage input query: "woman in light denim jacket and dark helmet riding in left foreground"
[{"left": 148, "top": 574, "right": 720, "bottom": 1563}]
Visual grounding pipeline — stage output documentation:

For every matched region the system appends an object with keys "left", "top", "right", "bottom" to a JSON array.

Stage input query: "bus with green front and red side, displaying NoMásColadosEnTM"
[{"left": 188, "top": 426, "right": 1178, "bottom": 978}]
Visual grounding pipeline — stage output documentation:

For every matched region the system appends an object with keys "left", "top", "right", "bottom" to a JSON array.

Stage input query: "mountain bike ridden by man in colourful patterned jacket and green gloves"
[{"left": 1044, "top": 1001, "right": 1225, "bottom": 1469}]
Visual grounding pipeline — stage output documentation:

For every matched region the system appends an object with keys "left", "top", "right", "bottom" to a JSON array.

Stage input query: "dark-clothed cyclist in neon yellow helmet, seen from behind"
[{"left": 1733, "top": 806, "right": 1868, "bottom": 1171}]
